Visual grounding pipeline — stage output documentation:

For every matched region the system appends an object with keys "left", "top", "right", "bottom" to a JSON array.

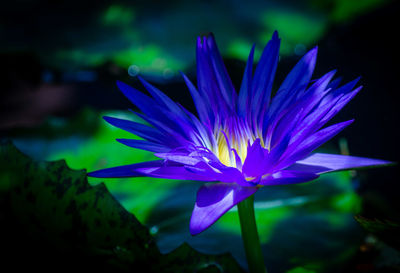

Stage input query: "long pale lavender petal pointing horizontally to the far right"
[{"left": 287, "top": 153, "right": 393, "bottom": 174}]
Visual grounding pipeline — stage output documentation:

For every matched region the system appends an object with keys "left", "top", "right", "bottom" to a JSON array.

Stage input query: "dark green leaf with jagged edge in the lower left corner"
[{"left": 0, "top": 141, "right": 243, "bottom": 272}]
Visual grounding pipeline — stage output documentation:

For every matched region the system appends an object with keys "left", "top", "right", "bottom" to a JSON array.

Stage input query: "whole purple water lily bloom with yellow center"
[{"left": 89, "top": 32, "right": 389, "bottom": 235}]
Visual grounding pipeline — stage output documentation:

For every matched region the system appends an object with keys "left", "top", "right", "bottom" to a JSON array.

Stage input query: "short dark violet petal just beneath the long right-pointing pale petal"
[{"left": 260, "top": 170, "right": 319, "bottom": 186}]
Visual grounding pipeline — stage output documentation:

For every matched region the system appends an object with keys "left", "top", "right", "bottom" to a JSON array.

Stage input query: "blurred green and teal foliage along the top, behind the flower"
[{"left": 0, "top": 0, "right": 390, "bottom": 76}]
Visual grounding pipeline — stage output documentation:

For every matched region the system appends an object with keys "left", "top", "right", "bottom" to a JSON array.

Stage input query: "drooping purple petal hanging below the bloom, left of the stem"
[{"left": 190, "top": 183, "right": 257, "bottom": 235}]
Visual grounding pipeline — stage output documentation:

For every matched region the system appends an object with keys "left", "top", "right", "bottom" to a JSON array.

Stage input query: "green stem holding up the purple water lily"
[{"left": 238, "top": 195, "right": 267, "bottom": 273}]
